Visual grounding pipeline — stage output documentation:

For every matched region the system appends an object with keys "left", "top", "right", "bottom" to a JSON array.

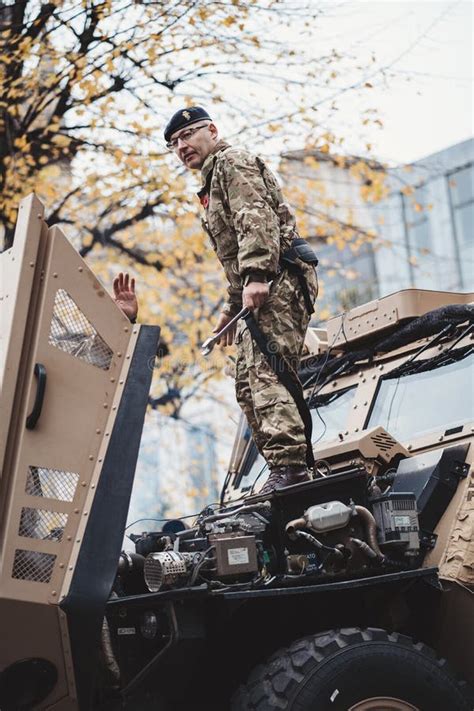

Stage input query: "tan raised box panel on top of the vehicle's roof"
[{"left": 327, "top": 289, "right": 474, "bottom": 348}]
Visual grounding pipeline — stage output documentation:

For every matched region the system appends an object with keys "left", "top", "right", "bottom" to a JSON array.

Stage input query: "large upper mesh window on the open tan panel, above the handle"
[{"left": 49, "top": 289, "right": 113, "bottom": 370}]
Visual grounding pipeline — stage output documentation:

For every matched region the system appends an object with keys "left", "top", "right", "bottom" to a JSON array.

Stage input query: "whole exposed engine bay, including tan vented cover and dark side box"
[{"left": 114, "top": 436, "right": 469, "bottom": 596}]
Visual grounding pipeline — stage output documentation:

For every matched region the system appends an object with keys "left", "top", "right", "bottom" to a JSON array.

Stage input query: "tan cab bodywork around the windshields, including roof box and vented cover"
[{"left": 231, "top": 289, "right": 474, "bottom": 683}]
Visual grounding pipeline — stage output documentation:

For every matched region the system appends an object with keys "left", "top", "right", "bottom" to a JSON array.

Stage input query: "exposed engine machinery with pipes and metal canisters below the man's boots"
[{"left": 121, "top": 495, "right": 420, "bottom": 592}]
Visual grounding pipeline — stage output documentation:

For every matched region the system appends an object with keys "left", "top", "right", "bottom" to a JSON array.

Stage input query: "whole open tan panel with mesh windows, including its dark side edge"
[{"left": 0, "top": 197, "right": 156, "bottom": 711}]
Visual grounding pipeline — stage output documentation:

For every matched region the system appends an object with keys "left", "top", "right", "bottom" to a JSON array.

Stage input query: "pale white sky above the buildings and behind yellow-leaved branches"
[{"left": 170, "top": 0, "right": 474, "bottom": 172}]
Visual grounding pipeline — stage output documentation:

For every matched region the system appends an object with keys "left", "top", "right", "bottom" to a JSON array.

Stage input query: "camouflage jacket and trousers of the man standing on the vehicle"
[{"left": 199, "top": 141, "right": 317, "bottom": 466}]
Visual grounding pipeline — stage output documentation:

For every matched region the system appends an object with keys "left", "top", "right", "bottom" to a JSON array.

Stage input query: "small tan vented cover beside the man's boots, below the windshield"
[{"left": 314, "top": 427, "right": 411, "bottom": 473}]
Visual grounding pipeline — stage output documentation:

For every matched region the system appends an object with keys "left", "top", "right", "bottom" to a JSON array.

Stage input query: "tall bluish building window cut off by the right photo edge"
[{"left": 447, "top": 163, "right": 474, "bottom": 289}]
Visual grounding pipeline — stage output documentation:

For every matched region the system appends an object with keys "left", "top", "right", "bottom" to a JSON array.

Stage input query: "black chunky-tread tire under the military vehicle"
[{"left": 232, "top": 628, "right": 473, "bottom": 711}]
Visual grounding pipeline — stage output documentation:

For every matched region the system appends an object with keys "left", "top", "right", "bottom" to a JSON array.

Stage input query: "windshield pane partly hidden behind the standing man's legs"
[{"left": 238, "top": 387, "right": 356, "bottom": 492}]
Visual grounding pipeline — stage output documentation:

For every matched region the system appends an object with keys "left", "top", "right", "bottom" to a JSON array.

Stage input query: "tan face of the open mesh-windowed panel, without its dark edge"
[{"left": 0, "top": 195, "right": 150, "bottom": 711}]
